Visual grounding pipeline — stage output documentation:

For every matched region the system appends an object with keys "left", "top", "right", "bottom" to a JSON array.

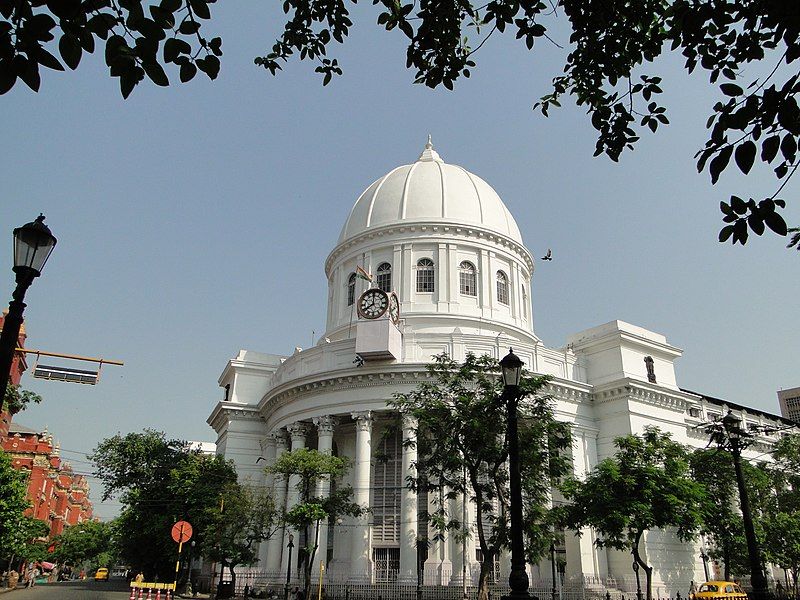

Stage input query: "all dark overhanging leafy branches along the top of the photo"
[{"left": 0, "top": 0, "right": 800, "bottom": 249}]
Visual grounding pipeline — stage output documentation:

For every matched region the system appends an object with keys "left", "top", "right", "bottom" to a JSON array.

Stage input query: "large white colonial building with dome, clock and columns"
[{"left": 208, "top": 141, "right": 788, "bottom": 596}]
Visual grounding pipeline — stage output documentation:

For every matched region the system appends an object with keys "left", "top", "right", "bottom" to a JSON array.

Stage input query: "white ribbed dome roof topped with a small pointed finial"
[{"left": 339, "top": 136, "right": 522, "bottom": 244}]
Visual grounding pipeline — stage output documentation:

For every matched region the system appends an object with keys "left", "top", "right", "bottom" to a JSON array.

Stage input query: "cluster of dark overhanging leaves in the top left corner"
[{"left": 0, "top": 0, "right": 222, "bottom": 98}]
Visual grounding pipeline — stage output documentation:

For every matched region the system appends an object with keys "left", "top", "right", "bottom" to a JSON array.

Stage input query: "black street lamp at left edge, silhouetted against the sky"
[{"left": 0, "top": 214, "right": 56, "bottom": 397}]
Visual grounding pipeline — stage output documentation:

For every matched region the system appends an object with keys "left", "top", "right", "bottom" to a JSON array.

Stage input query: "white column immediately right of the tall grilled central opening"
[{"left": 397, "top": 415, "right": 419, "bottom": 583}]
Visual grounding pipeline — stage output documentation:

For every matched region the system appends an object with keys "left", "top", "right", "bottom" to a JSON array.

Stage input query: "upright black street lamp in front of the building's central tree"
[{"left": 500, "top": 348, "right": 531, "bottom": 600}]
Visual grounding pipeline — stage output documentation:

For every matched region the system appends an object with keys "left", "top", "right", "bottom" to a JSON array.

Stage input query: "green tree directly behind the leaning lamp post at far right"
[{"left": 689, "top": 449, "right": 773, "bottom": 581}]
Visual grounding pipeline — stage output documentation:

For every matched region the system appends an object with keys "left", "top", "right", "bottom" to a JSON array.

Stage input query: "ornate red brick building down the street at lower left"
[{"left": 2, "top": 423, "right": 92, "bottom": 537}]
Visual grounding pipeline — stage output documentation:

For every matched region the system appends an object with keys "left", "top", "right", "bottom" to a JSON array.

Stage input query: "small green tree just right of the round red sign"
[{"left": 200, "top": 482, "right": 280, "bottom": 588}]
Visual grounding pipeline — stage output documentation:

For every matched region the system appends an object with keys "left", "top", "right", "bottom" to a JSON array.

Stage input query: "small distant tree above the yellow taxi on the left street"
[{"left": 52, "top": 521, "right": 116, "bottom": 570}]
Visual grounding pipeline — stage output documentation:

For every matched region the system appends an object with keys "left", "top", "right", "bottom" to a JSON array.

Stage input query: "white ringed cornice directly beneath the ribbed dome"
[{"left": 325, "top": 221, "right": 534, "bottom": 277}]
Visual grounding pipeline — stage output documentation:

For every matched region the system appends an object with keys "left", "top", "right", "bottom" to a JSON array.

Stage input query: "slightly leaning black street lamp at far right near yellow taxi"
[{"left": 720, "top": 410, "right": 769, "bottom": 600}]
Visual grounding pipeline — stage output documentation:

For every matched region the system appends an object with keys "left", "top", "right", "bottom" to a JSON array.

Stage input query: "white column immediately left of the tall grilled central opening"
[{"left": 350, "top": 411, "right": 372, "bottom": 581}]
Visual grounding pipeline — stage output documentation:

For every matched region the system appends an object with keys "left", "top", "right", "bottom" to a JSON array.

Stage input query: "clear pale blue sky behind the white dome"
[{"left": 0, "top": 2, "right": 800, "bottom": 519}]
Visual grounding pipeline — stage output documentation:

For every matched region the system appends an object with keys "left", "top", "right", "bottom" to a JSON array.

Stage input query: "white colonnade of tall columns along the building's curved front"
[{"left": 253, "top": 411, "right": 607, "bottom": 585}]
